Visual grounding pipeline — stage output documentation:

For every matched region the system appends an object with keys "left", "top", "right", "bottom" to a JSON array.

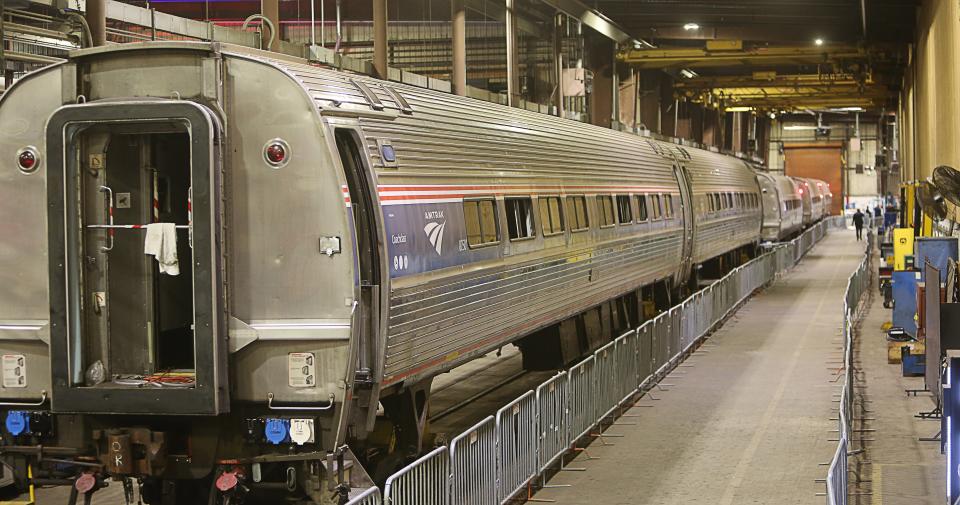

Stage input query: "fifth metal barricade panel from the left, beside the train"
[{"left": 536, "top": 371, "right": 569, "bottom": 474}]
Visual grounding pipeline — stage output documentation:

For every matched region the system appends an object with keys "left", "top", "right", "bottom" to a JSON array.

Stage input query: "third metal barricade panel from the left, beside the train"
[{"left": 449, "top": 416, "right": 497, "bottom": 505}]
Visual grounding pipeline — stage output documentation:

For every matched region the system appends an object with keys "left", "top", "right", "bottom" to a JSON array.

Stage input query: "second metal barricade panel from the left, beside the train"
[{"left": 383, "top": 447, "right": 450, "bottom": 505}]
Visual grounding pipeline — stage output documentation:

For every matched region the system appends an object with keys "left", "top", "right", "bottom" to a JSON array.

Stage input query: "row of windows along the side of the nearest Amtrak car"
[{"left": 463, "top": 194, "right": 674, "bottom": 247}]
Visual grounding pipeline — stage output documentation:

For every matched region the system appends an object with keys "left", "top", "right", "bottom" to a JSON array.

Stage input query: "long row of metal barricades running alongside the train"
[{"left": 376, "top": 218, "right": 840, "bottom": 505}]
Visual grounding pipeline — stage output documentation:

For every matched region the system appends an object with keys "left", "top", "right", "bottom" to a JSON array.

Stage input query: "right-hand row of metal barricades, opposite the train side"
[{"left": 826, "top": 223, "right": 874, "bottom": 505}]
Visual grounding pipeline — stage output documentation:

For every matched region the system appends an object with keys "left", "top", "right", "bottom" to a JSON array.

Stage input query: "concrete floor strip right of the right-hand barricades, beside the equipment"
[{"left": 849, "top": 250, "right": 946, "bottom": 505}]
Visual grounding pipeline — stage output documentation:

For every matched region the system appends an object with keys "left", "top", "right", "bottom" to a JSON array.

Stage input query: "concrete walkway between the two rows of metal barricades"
[{"left": 537, "top": 231, "right": 864, "bottom": 505}]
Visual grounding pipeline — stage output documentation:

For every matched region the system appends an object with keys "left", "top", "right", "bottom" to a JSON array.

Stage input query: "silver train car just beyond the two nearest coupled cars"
[{"left": 756, "top": 170, "right": 803, "bottom": 242}]
